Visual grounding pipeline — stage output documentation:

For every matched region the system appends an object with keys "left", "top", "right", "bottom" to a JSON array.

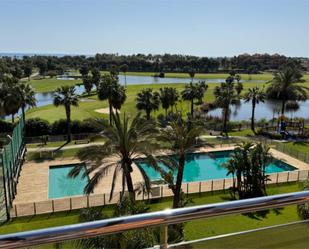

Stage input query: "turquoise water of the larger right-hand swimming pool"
[{"left": 136, "top": 151, "right": 295, "bottom": 182}]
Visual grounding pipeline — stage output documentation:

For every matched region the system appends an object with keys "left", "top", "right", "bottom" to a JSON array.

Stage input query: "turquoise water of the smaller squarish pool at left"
[{"left": 48, "top": 164, "right": 89, "bottom": 199}]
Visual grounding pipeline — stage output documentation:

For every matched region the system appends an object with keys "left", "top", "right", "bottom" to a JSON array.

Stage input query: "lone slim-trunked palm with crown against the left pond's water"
[{"left": 54, "top": 86, "right": 78, "bottom": 143}]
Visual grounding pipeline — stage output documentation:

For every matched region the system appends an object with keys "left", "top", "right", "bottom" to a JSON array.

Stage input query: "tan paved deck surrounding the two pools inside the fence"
[{"left": 13, "top": 146, "right": 309, "bottom": 204}]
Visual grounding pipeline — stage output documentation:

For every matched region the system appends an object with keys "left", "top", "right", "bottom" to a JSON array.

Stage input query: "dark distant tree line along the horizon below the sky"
[{"left": 0, "top": 54, "right": 302, "bottom": 79}]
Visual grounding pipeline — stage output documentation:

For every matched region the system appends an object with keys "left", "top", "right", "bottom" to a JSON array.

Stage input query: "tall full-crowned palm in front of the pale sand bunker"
[{"left": 97, "top": 74, "right": 126, "bottom": 124}]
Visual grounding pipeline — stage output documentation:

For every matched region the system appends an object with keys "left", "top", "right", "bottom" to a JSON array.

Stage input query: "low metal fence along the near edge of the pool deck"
[{"left": 10, "top": 170, "right": 309, "bottom": 217}]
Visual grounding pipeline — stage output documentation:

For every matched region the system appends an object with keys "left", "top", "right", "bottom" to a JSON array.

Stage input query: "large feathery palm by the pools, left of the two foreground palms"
[{"left": 70, "top": 113, "right": 157, "bottom": 200}]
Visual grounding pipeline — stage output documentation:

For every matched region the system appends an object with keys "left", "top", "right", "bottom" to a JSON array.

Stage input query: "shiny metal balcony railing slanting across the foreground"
[{"left": 0, "top": 191, "right": 309, "bottom": 248}]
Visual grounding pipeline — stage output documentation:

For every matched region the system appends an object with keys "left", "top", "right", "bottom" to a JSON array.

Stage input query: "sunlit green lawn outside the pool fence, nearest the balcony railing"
[{"left": 0, "top": 183, "right": 300, "bottom": 243}]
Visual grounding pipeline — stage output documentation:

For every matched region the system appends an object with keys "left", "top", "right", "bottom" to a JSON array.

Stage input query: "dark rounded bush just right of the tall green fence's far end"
[{"left": 25, "top": 118, "right": 51, "bottom": 137}]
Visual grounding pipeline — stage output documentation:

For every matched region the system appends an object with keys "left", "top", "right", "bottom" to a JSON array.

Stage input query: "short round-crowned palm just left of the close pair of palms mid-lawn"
[{"left": 136, "top": 88, "right": 160, "bottom": 120}]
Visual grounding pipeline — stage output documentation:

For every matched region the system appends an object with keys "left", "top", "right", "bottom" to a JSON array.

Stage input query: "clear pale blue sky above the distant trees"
[{"left": 0, "top": 0, "right": 309, "bottom": 57}]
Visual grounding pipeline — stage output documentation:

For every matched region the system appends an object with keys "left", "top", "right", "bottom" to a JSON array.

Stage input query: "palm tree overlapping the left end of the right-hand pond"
[{"left": 214, "top": 76, "right": 240, "bottom": 136}]
